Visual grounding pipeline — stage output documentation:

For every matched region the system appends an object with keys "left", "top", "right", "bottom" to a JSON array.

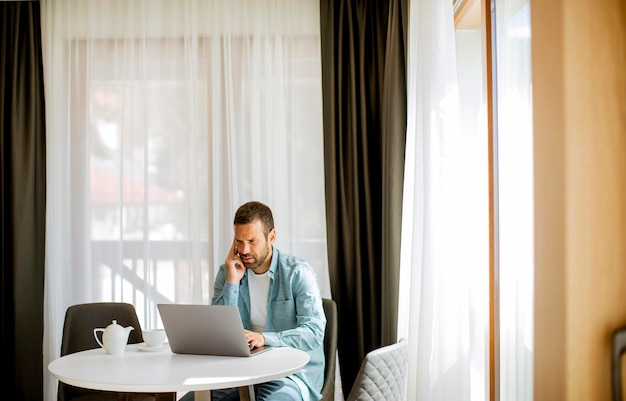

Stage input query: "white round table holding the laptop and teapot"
[{"left": 48, "top": 345, "right": 309, "bottom": 393}]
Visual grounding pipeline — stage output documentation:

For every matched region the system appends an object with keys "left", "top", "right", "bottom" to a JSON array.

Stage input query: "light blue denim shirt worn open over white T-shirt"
[{"left": 212, "top": 246, "right": 326, "bottom": 401}]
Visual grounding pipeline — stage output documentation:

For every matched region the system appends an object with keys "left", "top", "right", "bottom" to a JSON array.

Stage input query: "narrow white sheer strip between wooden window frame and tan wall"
[{"left": 495, "top": 0, "right": 534, "bottom": 401}]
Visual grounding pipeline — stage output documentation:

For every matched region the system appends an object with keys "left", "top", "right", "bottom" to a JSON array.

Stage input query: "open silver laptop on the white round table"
[{"left": 157, "top": 304, "right": 272, "bottom": 356}]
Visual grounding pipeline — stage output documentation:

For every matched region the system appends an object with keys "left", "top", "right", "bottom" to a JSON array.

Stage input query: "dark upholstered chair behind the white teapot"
[{"left": 57, "top": 302, "right": 176, "bottom": 401}]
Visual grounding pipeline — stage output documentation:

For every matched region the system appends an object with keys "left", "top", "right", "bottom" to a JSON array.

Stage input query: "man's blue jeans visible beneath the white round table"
[{"left": 180, "top": 377, "right": 302, "bottom": 401}]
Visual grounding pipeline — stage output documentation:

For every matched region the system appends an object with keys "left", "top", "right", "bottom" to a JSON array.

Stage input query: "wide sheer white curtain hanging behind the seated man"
[{"left": 41, "top": 0, "right": 330, "bottom": 400}]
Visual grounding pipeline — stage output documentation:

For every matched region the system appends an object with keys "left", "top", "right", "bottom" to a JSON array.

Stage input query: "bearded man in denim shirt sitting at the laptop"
[{"left": 185, "top": 202, "right": 326, "bottom": 401}]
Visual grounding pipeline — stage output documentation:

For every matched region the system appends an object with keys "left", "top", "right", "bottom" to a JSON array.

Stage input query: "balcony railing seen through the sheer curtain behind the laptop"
[{"left": 90, "top": 240, "right": 215, "bottom": 328}]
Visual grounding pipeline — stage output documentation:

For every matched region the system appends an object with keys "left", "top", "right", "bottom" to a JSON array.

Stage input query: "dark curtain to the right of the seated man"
[{"left": 320, "top": 0, "right": 408, "bottom": 395}]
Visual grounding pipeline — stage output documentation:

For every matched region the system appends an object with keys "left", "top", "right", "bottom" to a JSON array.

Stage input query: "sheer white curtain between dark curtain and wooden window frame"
[{"left": 398, "top": 0, "right": 489, "bottom": 401}]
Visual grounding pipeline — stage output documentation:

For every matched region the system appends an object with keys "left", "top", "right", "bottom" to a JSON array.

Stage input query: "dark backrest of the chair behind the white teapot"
[{"left": 57, "top": 302, "right": 143, "bottom": 401}]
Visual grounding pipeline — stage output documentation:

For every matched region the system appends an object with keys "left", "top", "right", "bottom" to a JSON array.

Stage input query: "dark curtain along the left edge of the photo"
[{"left": 0, "top": 1, "right": 46, "bottom": 400}]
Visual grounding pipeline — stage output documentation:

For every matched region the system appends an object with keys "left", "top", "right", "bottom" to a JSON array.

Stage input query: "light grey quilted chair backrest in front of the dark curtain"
[{"left": 346, "top": 339, "right": 409, "bottom": 401}]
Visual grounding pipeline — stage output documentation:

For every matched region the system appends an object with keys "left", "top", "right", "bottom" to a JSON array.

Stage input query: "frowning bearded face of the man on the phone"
[{"left": 235, "top": 219, "right": 276, "bottom": 270}]
